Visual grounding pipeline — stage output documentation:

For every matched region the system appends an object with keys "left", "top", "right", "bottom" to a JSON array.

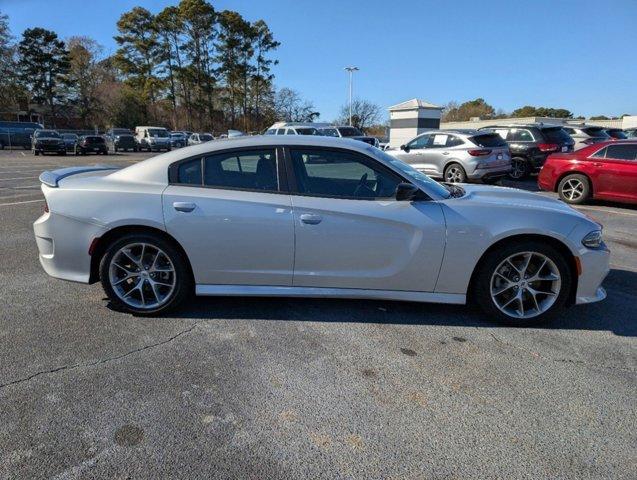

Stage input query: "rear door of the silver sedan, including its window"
[{"left": 163, "top": 147, "right": 294, "bottom": 286}]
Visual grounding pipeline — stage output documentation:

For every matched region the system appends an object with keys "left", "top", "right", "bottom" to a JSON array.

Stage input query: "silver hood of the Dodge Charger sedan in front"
[{"left": 461, "top": 185, "right": 588, "bottom": 218}]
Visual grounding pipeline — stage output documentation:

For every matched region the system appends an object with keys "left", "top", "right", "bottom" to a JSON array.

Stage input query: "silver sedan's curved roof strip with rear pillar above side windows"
[{"left": 109, "top": 135, "right": 374, "bottom": 184}]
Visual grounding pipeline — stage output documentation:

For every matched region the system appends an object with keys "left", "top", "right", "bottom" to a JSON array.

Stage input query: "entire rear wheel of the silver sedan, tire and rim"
[{"left": 100, "top": 234, "right": 192, "bottom": 315}]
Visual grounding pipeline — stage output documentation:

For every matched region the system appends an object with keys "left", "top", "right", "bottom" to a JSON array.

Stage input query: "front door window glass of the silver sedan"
[{"left": 290, "top": 149, "right": 402, "bottom": 200}]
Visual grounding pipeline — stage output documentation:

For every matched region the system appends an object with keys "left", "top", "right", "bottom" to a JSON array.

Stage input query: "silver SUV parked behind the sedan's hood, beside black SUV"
[{"left": 387, "top": 130, "right": 511, "bottom": 183}]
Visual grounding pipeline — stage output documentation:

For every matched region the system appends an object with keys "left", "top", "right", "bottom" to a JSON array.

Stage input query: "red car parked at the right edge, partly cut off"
[{"left": 537, "top": 140, "right": 637, "bottom": 204}]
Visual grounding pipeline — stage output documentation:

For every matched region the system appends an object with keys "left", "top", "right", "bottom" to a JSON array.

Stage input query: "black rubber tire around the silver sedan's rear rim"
[{"left": 100, "top": 233, "right": 194, "bottom": 316}]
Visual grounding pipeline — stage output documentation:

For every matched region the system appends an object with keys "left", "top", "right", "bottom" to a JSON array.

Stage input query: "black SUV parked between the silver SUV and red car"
[{"left": 479, "top": 123, "right": 575, "bottom": 180}]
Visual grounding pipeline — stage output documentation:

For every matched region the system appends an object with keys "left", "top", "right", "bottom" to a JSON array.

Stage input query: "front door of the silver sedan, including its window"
[{"left": 289, "top": 147, "right": 445, "bottom": 292}]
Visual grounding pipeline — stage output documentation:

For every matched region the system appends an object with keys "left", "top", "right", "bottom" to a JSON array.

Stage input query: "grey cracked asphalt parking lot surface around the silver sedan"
[{"left": 0, "top": 150, "right": 637, "bottom": 479}]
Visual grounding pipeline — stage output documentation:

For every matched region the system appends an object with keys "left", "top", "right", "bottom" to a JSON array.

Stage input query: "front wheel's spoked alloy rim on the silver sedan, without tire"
[{"left": 490, "top": 252, "right": 562, "bottom": 319}]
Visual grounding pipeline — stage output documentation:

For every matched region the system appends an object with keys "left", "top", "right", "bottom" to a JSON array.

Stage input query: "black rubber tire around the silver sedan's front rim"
[{"left": 469, "top": 240, "right": 573, "bottom": 327}]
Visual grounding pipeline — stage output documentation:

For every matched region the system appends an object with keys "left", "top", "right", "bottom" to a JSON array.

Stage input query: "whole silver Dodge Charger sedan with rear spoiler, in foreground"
[{"left": 34, "top": 136, "right": 609, "bottom": 325}]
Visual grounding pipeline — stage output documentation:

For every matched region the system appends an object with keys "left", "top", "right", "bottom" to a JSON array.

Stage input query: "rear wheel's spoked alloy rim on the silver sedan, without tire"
[{"left": 109, "top": 243, "right": 177, "bottom": 310}]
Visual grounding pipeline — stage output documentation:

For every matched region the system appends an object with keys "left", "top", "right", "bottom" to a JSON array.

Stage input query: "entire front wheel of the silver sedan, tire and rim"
[{"left": 472, "top": 241, "right": 573, "bottom": 326}]
